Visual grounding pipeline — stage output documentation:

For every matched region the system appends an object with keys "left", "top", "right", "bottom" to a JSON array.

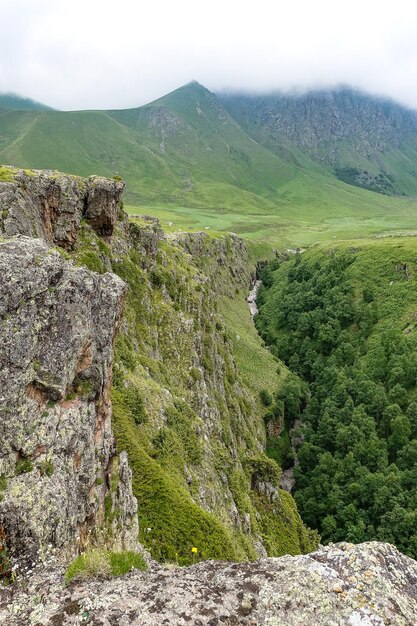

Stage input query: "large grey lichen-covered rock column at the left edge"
[{"left": 0, "top": 237, "right": 137, "bottom": 561}]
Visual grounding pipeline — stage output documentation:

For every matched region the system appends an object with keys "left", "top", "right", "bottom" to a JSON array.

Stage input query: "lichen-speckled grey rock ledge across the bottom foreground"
[{"left": 0, "top": 543, "right": 417, "bottom": 626}]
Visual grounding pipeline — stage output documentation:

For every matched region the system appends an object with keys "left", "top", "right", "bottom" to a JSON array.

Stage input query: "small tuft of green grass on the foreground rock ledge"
[{"left": 64, "top": 548, "right": 147, "bottom": 585}]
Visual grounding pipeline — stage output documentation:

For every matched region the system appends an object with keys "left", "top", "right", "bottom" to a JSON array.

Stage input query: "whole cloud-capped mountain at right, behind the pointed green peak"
[{"left": 219, "top": 88, "right": 417, "bottom": 195}]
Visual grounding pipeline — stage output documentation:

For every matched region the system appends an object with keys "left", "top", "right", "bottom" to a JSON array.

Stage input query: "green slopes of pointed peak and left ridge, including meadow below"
[{"left": 0, "top": 83, "right": 417, "bottom": 246}]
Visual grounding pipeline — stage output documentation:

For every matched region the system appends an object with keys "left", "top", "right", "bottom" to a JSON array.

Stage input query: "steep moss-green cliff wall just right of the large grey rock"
[{"left": 105, "top": 218, "right": 316, "bottom": 564}]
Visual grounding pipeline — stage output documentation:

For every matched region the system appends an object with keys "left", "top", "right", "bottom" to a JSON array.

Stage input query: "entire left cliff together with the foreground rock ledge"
[{"left": 0, "top": 170, "right": 417, "bottom": 626}]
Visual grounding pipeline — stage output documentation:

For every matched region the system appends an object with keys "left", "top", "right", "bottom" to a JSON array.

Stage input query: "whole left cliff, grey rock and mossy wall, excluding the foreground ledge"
[{"left": 0, "top": 168, "right": 316, "bottom": 563}]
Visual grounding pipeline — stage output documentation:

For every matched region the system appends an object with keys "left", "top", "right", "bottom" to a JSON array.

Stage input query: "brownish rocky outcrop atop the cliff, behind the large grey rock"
[{"left": 0, "top": 170, "right": 124, "bottom": 250}]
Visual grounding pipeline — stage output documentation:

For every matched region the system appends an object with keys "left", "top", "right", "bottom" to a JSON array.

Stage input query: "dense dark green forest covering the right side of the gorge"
[{"left": 257, "top": 238, "right": 417, "bottom": 558}]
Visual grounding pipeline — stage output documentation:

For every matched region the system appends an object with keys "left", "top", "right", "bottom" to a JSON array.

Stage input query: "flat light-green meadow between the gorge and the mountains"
[{"left": 126, "top": 174, "right": 417, "bottom": 248}]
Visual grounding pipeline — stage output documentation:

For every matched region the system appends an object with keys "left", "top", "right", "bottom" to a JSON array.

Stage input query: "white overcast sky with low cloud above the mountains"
[{"left": 0, "top": 0, "right": 417, "bottom": 109}]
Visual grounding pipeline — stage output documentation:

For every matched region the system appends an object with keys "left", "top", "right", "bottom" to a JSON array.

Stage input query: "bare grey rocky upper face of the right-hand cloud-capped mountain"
[{"left": 220, "top": 88, "right": 417, "bottom": 165}]
